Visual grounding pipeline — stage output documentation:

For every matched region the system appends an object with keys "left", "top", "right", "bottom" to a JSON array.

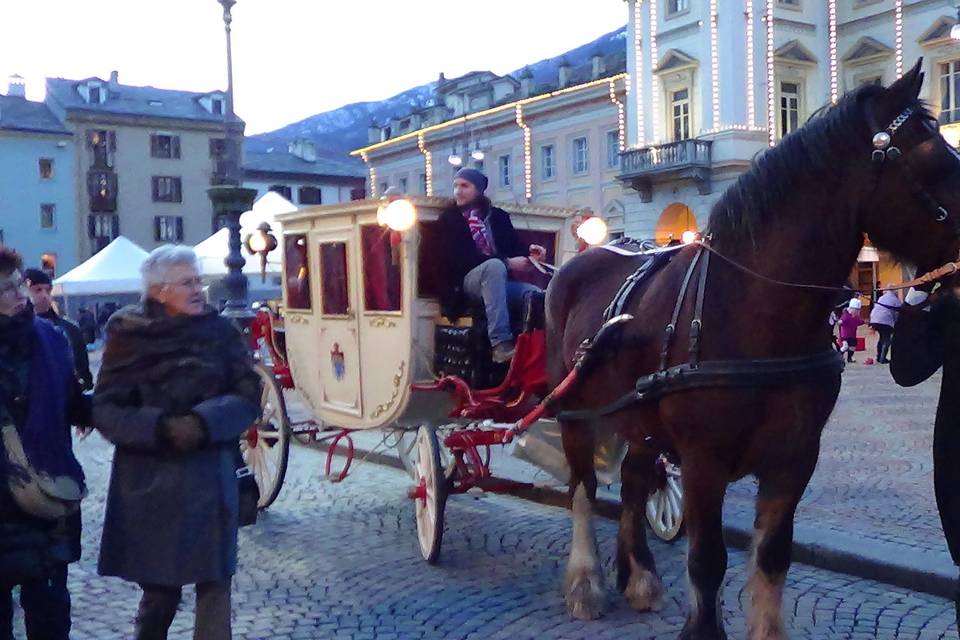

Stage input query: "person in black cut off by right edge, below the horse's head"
[{"left": 890, "top": 288, "right": 960, "bottom": 623}]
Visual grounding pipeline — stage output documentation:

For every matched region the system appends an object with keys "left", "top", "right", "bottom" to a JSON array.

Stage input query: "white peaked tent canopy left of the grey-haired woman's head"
[{"left": 53, "top": 236, "right": 148, "bottom": 296}]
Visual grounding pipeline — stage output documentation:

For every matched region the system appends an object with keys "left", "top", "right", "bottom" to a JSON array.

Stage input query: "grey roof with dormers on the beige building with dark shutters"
[{"left": 47, "top": 78, "right": 235, "bottom": 122}]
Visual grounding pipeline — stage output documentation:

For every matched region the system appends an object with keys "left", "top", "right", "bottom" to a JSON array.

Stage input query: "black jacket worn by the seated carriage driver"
[{"left": 438, "top": 198, "right": 529, "bottom": 318}]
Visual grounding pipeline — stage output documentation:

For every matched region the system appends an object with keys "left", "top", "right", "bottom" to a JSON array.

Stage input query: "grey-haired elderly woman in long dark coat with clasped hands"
[{"left": 93, "top": 245, "right": 260, "bottom": 640}]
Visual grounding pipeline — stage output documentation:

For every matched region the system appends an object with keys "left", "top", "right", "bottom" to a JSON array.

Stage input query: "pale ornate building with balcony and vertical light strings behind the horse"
[{"left": 621, "top": 0, "right": 960, "bottom": 291}]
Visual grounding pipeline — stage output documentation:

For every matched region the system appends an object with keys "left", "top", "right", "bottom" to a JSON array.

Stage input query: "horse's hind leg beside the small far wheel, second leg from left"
[{"left": 617, "top": 444, "right": 663, "bottom": 611}]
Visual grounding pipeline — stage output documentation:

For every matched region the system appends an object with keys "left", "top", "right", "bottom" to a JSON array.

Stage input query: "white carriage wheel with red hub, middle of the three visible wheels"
[{"left": 410, "top": 425, "right": 447, "bottom": 564}]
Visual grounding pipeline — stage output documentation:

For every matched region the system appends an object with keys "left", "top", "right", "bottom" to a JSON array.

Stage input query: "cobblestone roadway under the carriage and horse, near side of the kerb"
[{"left": 13, "top": 428, "right": 957, "bottom": 640}]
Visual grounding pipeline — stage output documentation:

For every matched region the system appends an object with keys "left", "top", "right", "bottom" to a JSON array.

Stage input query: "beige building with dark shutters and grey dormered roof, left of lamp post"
[{"left": 46, "top": 72, "right": 233, "bottom": 259}]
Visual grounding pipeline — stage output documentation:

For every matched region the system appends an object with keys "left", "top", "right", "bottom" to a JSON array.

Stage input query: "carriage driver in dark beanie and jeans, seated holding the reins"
[{"left": 438, "top": 168, "right": 546, "bottom": 362}]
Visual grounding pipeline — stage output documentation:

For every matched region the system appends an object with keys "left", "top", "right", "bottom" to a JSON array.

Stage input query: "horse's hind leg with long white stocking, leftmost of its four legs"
[{"left": 560, "top": 423, "right": 606, "bottom": 620}]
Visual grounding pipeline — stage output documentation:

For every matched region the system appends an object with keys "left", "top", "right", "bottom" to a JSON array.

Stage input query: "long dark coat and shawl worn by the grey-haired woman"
[{"left": 93, "top": 300, "right": 260, "bottom": 586}]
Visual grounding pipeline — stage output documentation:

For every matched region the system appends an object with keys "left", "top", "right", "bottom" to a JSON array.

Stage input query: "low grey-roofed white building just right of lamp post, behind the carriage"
[{"left": 243, "top": 139, "right": 366, "bottom": 206}]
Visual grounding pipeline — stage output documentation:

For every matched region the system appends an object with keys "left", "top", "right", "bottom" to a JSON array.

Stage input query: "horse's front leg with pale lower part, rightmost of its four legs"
[{"left": 747, "top": 447, "right": 819, "bottom": 640}]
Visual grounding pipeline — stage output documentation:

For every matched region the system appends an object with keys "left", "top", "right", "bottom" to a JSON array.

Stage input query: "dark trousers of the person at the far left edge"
[{"left": 0, "top": 565, "right": 70, "bottom": 640}]
